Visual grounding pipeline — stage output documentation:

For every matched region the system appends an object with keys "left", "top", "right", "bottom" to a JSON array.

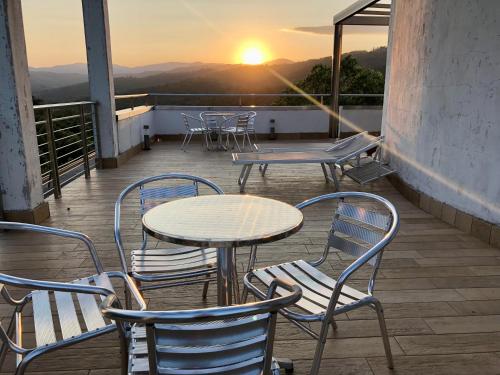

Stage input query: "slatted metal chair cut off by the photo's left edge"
[{"left": 0, "top": 222, "right": 146, "bottom": 375}]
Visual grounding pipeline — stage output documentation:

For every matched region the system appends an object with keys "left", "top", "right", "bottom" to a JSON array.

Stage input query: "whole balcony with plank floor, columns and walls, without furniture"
[{"left": 0, "top": 0, "right": 500, "bottom": 375}]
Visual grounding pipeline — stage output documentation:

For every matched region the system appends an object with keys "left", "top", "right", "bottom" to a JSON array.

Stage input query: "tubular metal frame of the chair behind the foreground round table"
[{"left": 114, "top": 173, "right": 224, "bottom": 307}]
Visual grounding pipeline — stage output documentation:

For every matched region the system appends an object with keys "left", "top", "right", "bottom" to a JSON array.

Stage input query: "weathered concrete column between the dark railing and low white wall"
[{"left": 82, "top": 0, "right": 118, "bottom": 168}]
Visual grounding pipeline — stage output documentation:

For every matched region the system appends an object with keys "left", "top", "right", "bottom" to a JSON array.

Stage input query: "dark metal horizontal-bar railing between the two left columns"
[{"left": 34, "top": 101, "right": 95, "bottom": 198}]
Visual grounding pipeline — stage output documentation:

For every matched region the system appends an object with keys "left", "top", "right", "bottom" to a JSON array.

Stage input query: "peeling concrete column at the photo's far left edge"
[{"left": 0, "top": 0, "right": 50, "bottom": 223}]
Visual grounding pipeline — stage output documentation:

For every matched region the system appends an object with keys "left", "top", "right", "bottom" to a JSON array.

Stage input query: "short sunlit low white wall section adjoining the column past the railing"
[{"left": 116, "top": 107, "right": 154, "bottom": 154}]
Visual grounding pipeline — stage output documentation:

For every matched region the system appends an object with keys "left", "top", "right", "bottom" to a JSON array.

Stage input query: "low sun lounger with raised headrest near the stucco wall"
[{"left": 233, "top": 132, "right": 393, "bottom": 192}]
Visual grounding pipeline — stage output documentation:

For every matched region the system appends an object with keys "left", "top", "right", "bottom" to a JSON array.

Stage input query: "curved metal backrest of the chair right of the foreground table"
[{"left": 296, "top": 192, "right": 399, "bottom": 294}]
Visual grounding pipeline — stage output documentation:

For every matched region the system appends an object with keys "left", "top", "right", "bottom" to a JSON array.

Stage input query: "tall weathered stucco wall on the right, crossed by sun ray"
[{"left": 382, "top": 0, "right": 500, "bottom": 224}]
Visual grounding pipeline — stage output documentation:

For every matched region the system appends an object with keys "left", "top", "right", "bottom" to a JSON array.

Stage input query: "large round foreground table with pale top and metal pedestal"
[{"left": 142, "top": 195, "right": 304, "bottom": 305}]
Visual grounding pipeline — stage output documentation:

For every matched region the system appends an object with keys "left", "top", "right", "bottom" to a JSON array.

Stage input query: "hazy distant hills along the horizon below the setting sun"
[{"left": 31, "top": 48, "right": 386, "bottom": 104}]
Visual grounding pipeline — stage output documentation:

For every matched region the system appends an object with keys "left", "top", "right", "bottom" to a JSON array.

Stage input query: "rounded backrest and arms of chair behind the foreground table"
[{"left": 115, "top": 173, "right": 224, "bottom": 272}]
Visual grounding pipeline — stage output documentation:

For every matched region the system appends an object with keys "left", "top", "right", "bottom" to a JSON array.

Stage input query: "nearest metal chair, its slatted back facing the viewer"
[{"left": 101, "top": 279, "right": 301, "bottom": 375}]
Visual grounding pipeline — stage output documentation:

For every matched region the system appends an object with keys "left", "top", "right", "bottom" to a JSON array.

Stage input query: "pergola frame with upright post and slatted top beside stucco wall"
[{"left": 328, "top": 0, "right": 391, "bottom": 138}]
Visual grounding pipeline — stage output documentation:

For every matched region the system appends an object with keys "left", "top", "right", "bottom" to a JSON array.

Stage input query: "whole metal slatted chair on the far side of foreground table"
[{"left": 115, "top": 173, "right": 224, "bottom": 307}]
